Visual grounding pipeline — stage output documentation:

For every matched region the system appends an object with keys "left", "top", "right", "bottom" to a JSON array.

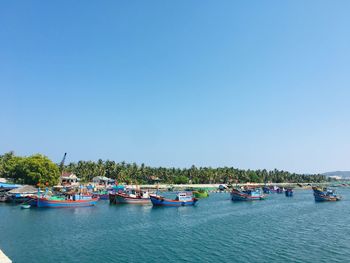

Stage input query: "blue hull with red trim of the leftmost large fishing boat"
[{"left": 30, "top": 198, "right": 98, "bottom": 208}]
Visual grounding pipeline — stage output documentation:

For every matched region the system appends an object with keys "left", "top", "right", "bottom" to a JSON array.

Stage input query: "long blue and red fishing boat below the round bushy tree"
[{"left": 30, "top": 194, "right": 98, "bottom": 208}]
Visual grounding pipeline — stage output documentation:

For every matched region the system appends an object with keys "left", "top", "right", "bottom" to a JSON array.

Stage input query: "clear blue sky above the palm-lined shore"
[{"left": 0, "top": 0, "right": 350, "bottom": 173}]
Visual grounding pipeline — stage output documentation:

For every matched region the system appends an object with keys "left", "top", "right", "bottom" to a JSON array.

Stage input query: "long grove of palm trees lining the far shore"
[{"left": 65, "top": 160, "right": 326, "bottom": 184}]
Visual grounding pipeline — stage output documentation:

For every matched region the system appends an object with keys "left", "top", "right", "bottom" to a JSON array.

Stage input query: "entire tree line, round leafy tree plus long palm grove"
[{"left": 0, "top": 152, "right": 327, "bottom": 185}]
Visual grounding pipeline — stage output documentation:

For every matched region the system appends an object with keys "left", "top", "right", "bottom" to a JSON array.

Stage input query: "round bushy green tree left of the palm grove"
[{"left": 0, "top": 152, "right": 60, "bottom": 185}]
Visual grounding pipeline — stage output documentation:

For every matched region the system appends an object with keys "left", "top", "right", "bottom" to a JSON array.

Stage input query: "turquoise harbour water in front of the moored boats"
[{"left": 0, "top": 189, "right": 350, "bottom": 263}]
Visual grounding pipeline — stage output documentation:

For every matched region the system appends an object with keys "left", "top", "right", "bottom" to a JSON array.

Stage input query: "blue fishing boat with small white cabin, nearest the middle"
[{"left": 150, "top": 192, "right": 198, "bottom": 206}]
